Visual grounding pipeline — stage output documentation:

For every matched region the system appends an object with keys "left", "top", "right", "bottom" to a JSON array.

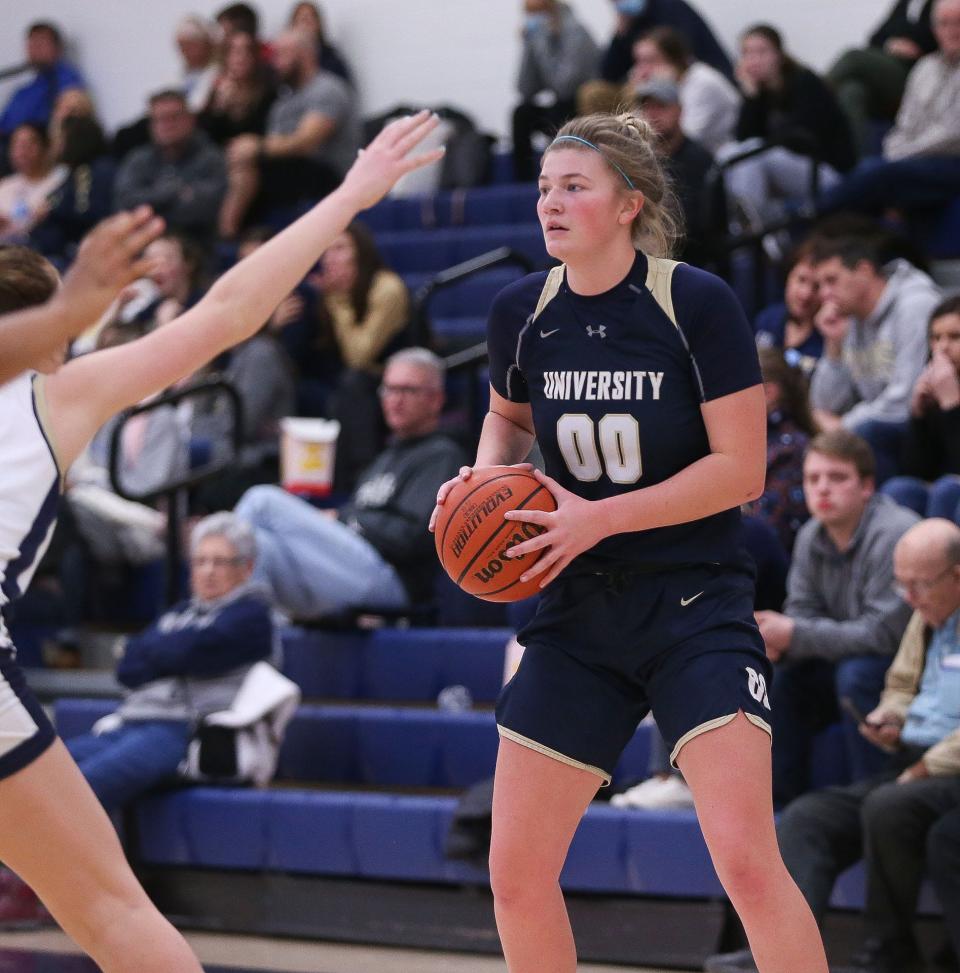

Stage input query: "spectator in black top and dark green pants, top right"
[{"left": 827, "top": 0, "right": 937, "bottom": 155}]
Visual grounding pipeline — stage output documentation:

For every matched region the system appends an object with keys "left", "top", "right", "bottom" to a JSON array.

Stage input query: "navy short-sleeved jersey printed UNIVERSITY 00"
[{"left": 487, "top": 252, "right": 761, "bottom": 570}]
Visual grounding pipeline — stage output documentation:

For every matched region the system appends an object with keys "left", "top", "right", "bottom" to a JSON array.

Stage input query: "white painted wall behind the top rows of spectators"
[{"left": 0, "top": 0, "right": 890, "bottom": 135}]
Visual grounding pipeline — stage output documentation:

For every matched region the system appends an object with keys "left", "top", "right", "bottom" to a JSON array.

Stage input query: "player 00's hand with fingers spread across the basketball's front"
[{"left": 503, "top": 470, "right": 609, "bottom": 588}]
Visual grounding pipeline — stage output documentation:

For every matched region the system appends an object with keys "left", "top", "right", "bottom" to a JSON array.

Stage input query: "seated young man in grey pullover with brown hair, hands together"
[{"left": 757, "top": 429, "right": 918, "bottom": 804}]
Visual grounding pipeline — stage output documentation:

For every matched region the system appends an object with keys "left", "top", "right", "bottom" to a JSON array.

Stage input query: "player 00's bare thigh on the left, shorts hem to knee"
[{"left": 490, "top": 738, "right": 602, "bottom": 891}]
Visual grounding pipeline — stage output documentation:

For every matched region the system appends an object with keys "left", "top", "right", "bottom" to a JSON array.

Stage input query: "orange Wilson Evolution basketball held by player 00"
[{"left": 434, "top": 466, "right": 557, "bottom": 601}]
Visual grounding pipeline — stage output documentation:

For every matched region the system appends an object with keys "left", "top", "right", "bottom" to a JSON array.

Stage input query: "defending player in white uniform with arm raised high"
[{"left": 0, "top": 112, "right": 441, "bottom": 973}]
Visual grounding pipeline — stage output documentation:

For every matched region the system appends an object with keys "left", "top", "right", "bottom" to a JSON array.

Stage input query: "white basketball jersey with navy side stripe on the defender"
[{"left": 0, "top": 372, "right": 60, "bottom": 648}]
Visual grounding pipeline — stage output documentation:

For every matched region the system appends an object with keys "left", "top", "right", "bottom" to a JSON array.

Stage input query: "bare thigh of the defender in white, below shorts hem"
[{"left": 0, "top": 740, "right": 151, "bottom": 916}]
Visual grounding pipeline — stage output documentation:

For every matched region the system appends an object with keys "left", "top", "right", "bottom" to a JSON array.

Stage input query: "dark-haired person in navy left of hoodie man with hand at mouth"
[{"left": 753, "top": 240, "right": 823, "bottom": 377}]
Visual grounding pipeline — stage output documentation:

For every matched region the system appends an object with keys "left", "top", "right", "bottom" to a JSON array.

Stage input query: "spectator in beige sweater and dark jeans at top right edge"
[{"left": 817, "top": 0, "right": 960, "bottom": 220}]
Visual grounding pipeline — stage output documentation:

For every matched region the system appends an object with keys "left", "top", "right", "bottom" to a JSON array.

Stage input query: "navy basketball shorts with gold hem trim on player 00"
[{"left": 497, "top": 565, "right": 772, "bottom": 784}]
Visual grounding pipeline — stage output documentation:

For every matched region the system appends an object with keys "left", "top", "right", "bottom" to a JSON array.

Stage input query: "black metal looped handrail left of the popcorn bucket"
[{"left": 109, "top": 376, "right": 243, "bottom": 605}]
